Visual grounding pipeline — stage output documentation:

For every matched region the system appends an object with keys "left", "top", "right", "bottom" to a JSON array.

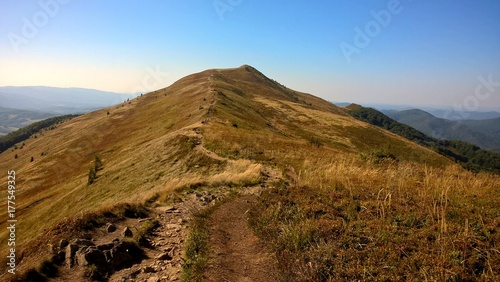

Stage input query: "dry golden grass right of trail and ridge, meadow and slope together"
[{"left": 198, "top": 67, "right": 500, "bottom": 281}]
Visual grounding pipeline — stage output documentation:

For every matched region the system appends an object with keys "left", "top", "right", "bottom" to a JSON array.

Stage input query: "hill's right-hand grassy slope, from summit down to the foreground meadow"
[{"left": 201, "top": 66, "right": 449, "bottom": 166}]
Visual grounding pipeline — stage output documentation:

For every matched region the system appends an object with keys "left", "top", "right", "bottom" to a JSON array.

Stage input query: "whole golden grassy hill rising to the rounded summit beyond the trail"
[{"left": 0, "top": 65, "right": 448, "bottom": 249}]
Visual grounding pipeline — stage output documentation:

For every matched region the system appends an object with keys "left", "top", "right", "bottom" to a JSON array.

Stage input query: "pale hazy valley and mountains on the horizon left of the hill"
[{"left": 0, "top": 86, "right": 135, "bottom": 136}]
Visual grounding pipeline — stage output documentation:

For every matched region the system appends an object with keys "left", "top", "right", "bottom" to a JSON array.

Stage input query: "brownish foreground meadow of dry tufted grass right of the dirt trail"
[{"left": 251, "top": 155, "right": 500, "bottom": 281}]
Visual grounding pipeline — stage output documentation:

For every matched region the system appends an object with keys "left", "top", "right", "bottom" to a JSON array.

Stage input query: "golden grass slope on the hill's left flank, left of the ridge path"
[{"left": 0, "top": 67, "right": 225, "bottom": 275}]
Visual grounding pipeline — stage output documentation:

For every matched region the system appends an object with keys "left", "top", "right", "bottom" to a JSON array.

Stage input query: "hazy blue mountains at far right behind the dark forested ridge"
[{"left": 382, "top": 109, "right": 500, "bottom": 152}]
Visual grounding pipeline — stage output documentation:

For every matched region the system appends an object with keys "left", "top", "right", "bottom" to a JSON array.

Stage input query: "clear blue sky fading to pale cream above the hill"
[{"left": 0, "top": 0, "right": 500, "bottom": 109}]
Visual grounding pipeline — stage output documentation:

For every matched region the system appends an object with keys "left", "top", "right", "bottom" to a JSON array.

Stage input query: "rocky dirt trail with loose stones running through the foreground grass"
[{"left": 51, "top": 128, "right": 281, "bottom": 282}]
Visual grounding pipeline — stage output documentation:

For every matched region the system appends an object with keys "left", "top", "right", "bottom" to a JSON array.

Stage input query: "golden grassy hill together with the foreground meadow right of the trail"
[{"left": 0, "top": 65, "right": 500, "bottom": 280}]
